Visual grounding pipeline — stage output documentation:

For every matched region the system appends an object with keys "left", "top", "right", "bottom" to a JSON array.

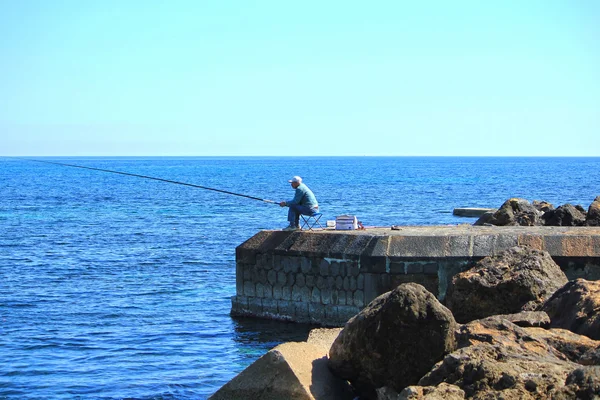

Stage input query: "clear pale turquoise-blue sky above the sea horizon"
[{"left": 0, "top": 0, "right": 600, "bottom": 156}]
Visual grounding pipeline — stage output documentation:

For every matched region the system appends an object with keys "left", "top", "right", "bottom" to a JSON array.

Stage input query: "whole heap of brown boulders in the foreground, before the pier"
[{"left": 211, "top": 244, "right": 600, "bottom": 400}]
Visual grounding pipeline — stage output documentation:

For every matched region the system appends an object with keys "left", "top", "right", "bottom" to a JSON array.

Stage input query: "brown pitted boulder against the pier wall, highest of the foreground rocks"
[{"left": 446, "top": 247, "right": 567, "bottom": 323}]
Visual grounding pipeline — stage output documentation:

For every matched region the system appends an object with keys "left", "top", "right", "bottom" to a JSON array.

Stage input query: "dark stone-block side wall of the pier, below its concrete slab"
[{"left": 231, "top": 253, "right": 466, "bottom": 326}]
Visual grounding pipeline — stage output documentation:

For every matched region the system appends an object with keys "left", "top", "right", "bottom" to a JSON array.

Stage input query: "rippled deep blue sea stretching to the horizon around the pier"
[{"left": 0, "top": 157, "right": 600, "bottom": 399}]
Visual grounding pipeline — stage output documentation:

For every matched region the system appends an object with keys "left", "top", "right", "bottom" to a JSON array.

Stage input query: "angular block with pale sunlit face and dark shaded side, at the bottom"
[{"left": 209, "top": 342, "right": 353, "bottom": 400}]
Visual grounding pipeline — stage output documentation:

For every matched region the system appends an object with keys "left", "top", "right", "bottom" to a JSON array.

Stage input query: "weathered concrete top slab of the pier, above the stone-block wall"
[{"left": 236, "top": 224, "right": 600, "bottom": 262}]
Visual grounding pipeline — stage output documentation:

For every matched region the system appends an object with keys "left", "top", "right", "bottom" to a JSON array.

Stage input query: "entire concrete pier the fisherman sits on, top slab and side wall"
[{"left": 231, "top": 225, "right": 600, "bottom": 326}]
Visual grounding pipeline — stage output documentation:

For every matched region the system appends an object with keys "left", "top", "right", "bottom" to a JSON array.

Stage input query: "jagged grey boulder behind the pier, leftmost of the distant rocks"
[{"left": 475, "top": 198, "right": 542, "bottom": 226}]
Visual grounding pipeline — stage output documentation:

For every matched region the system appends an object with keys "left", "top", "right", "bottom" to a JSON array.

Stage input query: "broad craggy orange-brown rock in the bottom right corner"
[{"left": 419, "top": 316, "right": 600, "bottom": 400}]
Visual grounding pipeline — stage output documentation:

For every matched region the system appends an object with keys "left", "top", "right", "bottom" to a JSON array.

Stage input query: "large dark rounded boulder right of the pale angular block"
[{"left": 329, "top": 283, "right": 458, "bottom": 399}]
